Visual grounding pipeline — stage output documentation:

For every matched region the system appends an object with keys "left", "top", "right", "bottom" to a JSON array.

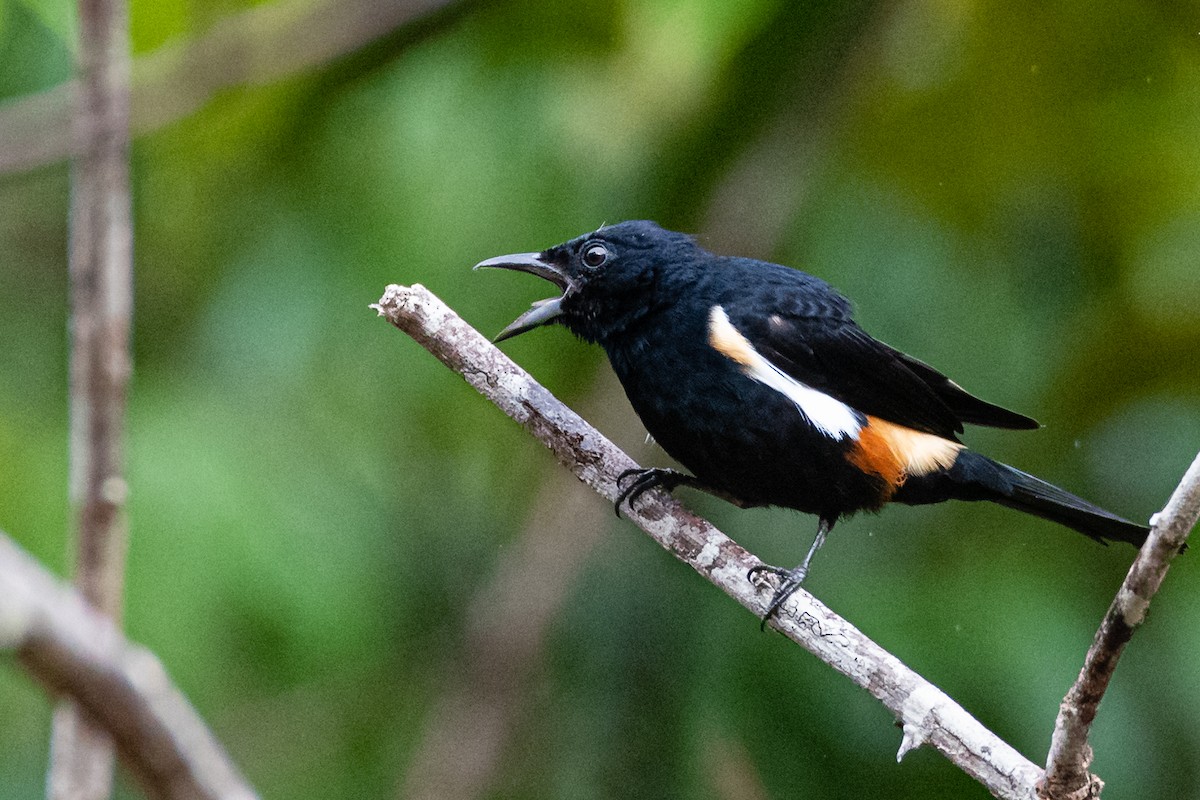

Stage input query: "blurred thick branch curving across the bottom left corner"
[{"left": 0, "top": 533, "right": 257, "bottom": 800}]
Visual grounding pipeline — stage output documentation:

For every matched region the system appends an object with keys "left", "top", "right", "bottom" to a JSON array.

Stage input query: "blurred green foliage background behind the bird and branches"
[{"left": 0, "top": 0, "right": 1200, "bottom": 799}]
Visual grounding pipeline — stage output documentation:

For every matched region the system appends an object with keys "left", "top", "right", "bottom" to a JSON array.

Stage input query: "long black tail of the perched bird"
[{"left": 895, "top": 450, "right": 1150, "bottom": 547}]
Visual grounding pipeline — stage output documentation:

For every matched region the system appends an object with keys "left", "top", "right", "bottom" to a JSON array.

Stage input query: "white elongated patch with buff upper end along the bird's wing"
[{"left": 708, "top": 306, "right": 863, "bottom": 439}]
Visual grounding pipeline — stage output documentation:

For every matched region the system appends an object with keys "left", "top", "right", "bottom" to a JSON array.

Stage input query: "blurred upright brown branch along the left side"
[{"left": 47, "top": 0, "right": 133, "bottom": 800}]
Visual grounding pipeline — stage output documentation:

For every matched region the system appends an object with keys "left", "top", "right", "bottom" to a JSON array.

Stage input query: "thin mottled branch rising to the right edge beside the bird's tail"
[{"left": 1039, "top": 455, "right": 1200, "bottom": 800}]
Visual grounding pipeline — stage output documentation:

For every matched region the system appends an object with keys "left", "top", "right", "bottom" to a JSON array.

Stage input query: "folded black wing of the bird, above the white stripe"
[{"left": 724, "top": 270, "right": 1037, "bottom": 440}]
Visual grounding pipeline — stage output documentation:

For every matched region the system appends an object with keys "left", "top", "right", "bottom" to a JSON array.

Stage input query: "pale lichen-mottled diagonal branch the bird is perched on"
[{"left": 372, "top": 284, "right": 1042, "bottom": 800}]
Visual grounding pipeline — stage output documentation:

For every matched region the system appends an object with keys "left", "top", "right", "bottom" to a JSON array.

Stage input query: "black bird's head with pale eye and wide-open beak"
[{"left": 475, "top": 221, "right": 703, "bottom": 343}]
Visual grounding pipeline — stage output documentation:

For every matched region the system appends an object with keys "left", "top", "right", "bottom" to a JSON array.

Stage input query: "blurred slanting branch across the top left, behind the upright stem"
[{"left": 0, "top": 0, "right": 465, "bottom": 174}]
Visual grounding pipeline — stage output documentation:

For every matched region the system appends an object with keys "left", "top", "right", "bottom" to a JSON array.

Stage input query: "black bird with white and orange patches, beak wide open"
[{"left": 476, "top": 222, "right": 1147, "bottom": 624}]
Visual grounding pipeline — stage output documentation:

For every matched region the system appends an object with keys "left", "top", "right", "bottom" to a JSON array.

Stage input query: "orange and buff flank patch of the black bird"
[{"left": 846, "top": 415, "right": 964, "bottom": 488}]
